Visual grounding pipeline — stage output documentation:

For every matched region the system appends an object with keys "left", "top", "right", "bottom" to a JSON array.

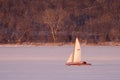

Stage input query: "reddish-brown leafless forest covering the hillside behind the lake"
[{"left": 0, "top": 0, "right": 120, "bottom": 44}]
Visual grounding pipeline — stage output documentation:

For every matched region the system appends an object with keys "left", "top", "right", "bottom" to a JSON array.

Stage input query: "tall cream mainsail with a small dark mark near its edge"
[{"left": 73, "top": 38, "right": 81, "bottom": 63}]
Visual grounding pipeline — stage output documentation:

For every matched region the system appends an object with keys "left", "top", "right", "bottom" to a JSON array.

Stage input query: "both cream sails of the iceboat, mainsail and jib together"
[{"left": 67, "top": 38, "right": 81, "bottom": 63}]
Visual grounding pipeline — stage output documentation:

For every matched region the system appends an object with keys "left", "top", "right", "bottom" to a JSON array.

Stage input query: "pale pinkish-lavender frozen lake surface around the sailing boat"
[{"left": 0, "top": 46, "right": 120, "bottom": 80}]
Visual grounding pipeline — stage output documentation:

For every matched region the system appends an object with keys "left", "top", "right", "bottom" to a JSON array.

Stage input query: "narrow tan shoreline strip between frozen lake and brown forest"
[{"left": 0, "top": 42, "right": 120, "bottom": 47}]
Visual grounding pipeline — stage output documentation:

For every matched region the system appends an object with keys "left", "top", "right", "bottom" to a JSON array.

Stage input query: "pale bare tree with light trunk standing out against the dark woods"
[{"left": 43, "top": 9, "right": 66, "bottom": 42}]
